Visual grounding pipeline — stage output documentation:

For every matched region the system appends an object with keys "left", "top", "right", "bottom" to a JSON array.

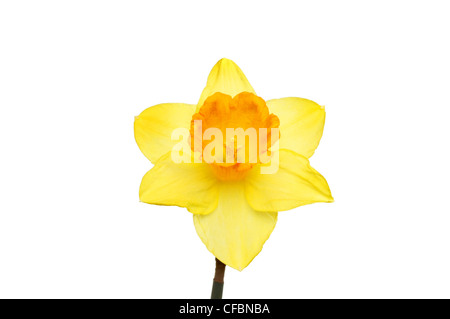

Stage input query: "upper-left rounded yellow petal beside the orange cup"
[{"left": 134, "top": 103, "right": 195, "bottom": 163}]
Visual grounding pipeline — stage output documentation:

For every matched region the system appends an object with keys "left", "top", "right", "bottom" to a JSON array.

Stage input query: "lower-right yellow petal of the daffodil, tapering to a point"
[{"left": 245, "top": 150, "right": 333, "bottom": 212}]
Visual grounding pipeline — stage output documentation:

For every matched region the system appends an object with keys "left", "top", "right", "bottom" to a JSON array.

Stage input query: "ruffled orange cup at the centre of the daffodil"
[{"left": 190, "top": 92, "right": 280, "bottom": 180}]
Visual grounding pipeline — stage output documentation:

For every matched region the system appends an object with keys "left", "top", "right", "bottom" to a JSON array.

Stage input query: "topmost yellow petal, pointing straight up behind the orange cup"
[{"left": 197, "top": 58, "right": 256, "bottom": 110}]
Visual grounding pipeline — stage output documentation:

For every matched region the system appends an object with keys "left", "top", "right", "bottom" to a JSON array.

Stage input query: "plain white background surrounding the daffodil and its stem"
[{"left": 0, "top": 0, "right": 450, "bottom": 298}]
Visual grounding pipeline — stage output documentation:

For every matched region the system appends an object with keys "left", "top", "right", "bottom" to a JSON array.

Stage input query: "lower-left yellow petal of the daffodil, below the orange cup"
[{"left": 139, "top": 152, "right": 219, "bottom": 214}]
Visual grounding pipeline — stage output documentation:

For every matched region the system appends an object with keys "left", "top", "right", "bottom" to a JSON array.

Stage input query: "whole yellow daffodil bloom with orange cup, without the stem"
[{"left": 134, "top": 59, "right": 333, "bottom": 270}]
